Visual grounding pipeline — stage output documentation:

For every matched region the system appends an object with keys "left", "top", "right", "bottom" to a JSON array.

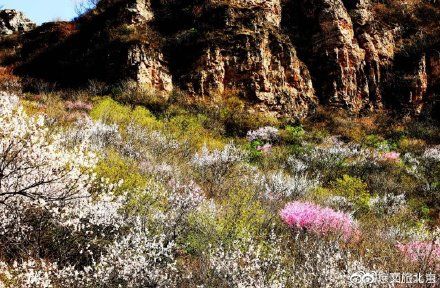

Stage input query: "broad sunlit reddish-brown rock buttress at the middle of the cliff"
[{"left": 170, "top": 0, "right": 317, "bottom": 117}]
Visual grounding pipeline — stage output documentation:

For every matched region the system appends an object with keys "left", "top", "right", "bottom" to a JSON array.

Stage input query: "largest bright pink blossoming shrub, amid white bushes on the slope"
[{"left": 280, "top": 201, "right": 358, "bottom": 240}]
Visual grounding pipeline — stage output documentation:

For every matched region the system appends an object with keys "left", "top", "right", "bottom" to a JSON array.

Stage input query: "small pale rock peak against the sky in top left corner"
[{"left": 0, "top": 9, "right": 36, "bottom": 35}]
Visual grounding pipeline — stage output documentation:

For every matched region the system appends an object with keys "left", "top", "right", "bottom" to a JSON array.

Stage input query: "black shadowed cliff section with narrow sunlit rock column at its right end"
[{"left": 16, "top": 0, "right": 173, "bottom": 93}]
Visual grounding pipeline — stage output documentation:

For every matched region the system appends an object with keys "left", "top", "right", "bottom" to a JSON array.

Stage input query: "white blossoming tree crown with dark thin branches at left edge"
[{"left": 0, "top": 94, "right": 96, "bottom": 206}]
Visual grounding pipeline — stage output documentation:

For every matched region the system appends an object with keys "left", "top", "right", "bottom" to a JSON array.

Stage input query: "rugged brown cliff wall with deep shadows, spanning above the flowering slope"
[{"left": 0, "top": 0, "right": 440, "bottom": 117}]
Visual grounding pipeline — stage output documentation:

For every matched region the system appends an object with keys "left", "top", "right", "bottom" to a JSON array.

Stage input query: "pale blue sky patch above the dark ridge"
[{"left": 0, "top": 0, "right": 82, "bottom": 24}]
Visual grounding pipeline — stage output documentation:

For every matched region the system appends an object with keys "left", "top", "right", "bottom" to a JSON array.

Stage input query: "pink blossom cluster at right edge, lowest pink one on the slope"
[{"left": 397, "top": 241, "right": 440, "bottom": 263}]
